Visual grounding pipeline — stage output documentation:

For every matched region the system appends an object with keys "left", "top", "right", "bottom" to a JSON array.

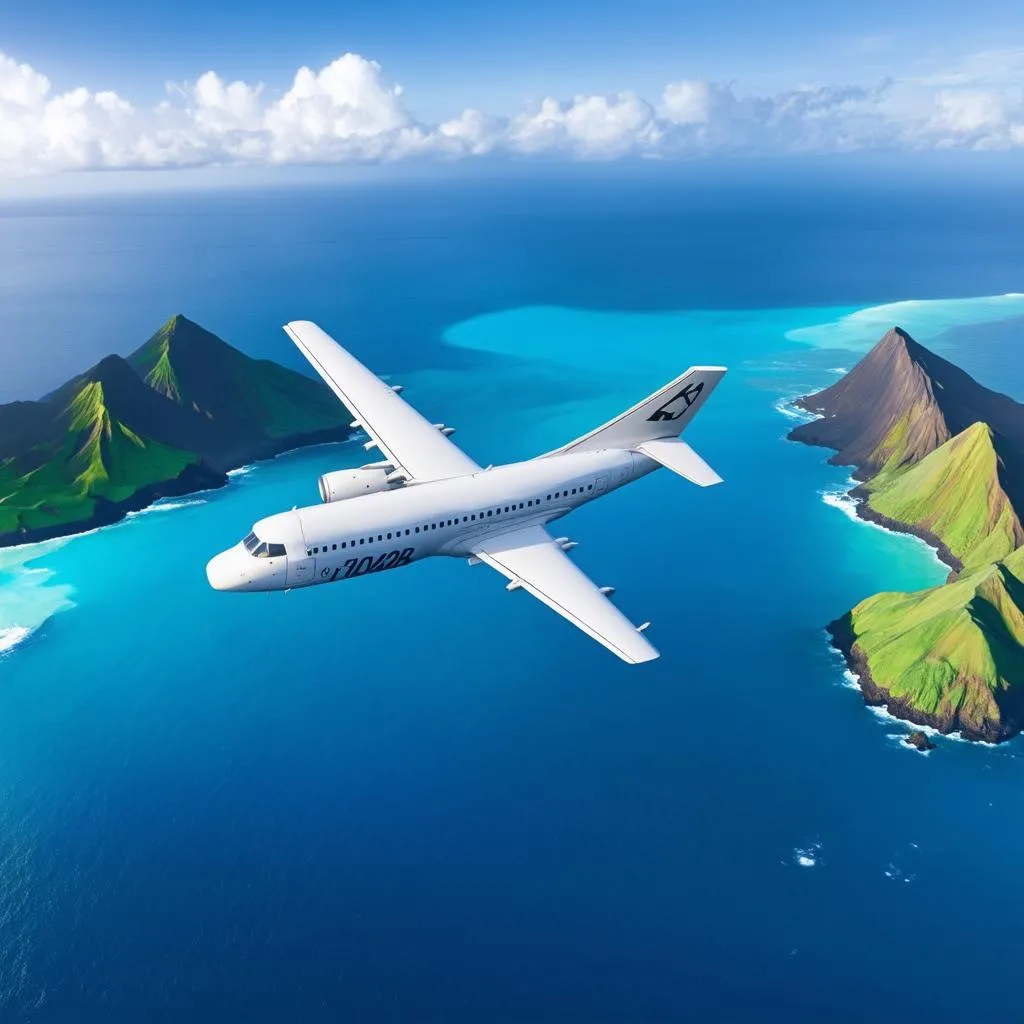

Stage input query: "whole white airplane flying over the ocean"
[{"left": 206, "top": 321, "right": 726, "bottom": 665}]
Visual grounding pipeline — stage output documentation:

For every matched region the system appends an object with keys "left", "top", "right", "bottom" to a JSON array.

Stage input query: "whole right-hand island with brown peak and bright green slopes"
[{"left": 790, "top": 328, "right": 1024, "bottom": 742}]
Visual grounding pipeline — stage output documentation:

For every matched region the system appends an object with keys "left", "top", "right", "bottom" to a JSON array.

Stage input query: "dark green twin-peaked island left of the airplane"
[{"left": 0, "top": 313, "right": 351, "bottom": 547}]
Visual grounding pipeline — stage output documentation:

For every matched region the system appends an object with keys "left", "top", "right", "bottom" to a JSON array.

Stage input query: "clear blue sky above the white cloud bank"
[{"left": 8, "top": 0, "right": 1024, "bottom": 120}]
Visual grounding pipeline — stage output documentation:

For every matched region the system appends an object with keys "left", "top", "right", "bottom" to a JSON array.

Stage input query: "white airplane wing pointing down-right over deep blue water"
[{"left": 473, "top": 526, "right": 658, "bottom": 665}]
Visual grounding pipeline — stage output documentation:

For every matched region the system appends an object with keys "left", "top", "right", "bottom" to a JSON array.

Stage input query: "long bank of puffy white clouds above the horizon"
[{"left": 0, "top": 51, "right": 1024, "bottom": 176}]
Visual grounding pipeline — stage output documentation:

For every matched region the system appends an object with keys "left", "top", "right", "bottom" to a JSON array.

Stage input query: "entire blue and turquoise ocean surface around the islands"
[{"left": 0, "top": 163, "right": 1024, "bottom": 1022}]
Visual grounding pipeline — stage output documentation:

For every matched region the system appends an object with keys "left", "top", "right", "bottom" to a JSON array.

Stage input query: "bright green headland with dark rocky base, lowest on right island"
[{"left": 829, "top": 548, "right": 1024, "bottom": 742}]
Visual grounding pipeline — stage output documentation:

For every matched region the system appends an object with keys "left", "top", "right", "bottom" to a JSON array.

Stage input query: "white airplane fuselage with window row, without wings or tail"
[{"left": 207, "top": 449, "right": 658, "bottom": 591}]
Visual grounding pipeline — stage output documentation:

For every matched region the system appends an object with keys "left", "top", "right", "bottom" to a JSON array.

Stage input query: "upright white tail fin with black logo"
[{"left": 549, "top": 367, "right": 725, "bottom": 455}]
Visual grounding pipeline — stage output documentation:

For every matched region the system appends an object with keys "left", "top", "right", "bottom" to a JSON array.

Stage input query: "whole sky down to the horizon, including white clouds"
[{"left": 0, "top": 0, "right": 1024, "bottom": 190}]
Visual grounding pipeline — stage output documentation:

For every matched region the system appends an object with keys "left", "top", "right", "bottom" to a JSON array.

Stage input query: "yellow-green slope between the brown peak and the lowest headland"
[{"left": 863, "top": 423, "right": 1024, "bottom": 570}]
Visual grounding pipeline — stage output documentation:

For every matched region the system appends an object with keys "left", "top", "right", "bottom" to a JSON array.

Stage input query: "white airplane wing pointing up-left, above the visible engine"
[{"left": 285, "top": 321, "right": 480, "bottom": 480}]
